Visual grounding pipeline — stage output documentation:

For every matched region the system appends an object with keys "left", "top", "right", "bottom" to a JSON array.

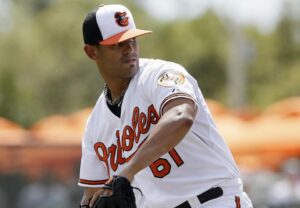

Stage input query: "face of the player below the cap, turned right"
[{"left": 95, "top": 38, "right": 139, "bottom": 79}]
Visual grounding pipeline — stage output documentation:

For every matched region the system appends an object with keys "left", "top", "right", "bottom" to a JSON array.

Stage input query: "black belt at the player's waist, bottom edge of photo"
[{"left": 175, "top": 187, "right": 223, "bottom": 208}]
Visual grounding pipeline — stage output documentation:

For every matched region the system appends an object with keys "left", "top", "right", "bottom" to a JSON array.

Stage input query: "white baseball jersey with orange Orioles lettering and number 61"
[{"left": 78, "top": 59, "right": 239, "bottom": 208}]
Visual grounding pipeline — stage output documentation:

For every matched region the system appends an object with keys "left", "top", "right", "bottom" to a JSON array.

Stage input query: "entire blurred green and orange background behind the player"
[{"left": 0, "top": 0, "right": 300, "bottom": 208}]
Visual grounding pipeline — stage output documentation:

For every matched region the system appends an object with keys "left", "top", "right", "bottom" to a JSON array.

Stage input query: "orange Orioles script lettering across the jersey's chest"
[{"left": 94, "top": 105, "right": 160, "bottom": 171}]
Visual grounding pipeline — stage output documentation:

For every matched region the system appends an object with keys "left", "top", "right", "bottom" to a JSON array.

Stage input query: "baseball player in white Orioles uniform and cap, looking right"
[{"left": 78, "top": 5, "right": 252, "bottom": 208}]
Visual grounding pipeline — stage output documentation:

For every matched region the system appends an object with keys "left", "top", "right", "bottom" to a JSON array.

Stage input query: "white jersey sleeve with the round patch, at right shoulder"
[{"left": 143, "top": 62, "right": 198, "bottom": 115}]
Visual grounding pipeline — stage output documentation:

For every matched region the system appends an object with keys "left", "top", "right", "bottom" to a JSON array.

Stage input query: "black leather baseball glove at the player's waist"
[{"left": 93, "top": 176, "right": 139, "bottom": 208}]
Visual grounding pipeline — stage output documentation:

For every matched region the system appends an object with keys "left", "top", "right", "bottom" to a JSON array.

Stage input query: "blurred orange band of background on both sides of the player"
[{"left": 0, "top": 97, "right": 300, "bottom": 180}]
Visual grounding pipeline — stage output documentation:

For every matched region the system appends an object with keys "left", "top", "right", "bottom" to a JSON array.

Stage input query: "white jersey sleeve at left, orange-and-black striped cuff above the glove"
[{"left": 78, "top": 122, "right": 109, "bottom": 188}]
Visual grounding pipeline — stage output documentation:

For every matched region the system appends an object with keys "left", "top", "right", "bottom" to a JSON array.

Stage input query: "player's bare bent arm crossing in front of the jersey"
[{"left": 120, "top": 97, "right": 197, "bottom": 181}]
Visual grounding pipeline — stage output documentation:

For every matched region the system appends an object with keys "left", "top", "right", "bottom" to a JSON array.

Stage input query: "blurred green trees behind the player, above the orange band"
[{"left": 0, "top": 0, "right": 300, "bottom": 127}]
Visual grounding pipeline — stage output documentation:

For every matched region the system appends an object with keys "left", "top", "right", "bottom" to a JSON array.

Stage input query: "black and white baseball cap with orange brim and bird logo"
[{"left": 82, "top": 4, "right": 152, "bottom": 45}]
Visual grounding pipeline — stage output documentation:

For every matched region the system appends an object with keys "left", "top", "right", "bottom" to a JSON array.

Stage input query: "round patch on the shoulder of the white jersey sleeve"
[{"left": 157, "top": 71, "right": 185, "bottom": 87}]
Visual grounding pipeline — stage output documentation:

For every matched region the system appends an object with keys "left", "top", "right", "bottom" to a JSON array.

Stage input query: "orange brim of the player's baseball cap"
[{"left": 100, "top": 29, "right": 152, "bottom": 45}]
